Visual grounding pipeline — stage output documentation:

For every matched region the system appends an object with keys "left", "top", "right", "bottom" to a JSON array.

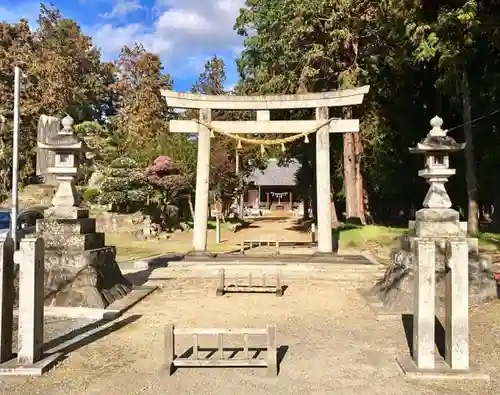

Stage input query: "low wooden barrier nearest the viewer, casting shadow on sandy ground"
[{"left": 165, "top": 325, "right": 278, "bottom": 377}]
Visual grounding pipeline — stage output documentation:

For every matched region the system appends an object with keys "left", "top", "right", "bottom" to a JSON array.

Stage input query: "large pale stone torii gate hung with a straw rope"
[{"left": 161, "top": 85, "right": 370, "bottom": 255}]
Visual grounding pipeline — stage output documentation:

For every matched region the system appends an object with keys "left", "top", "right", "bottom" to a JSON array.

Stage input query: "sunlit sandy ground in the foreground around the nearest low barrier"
[{"left": 0, "top": 280, "right": 500, "bottom": 395}]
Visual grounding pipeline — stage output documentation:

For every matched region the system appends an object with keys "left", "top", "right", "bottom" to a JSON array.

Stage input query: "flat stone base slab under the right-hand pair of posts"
[{"left": 396, "top": 355, "right": 490, "bottom": 381}]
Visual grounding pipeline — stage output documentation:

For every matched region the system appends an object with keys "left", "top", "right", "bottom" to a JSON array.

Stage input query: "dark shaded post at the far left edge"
[{"left": 0, "top": 238, "right": 14, "bottom": 363}]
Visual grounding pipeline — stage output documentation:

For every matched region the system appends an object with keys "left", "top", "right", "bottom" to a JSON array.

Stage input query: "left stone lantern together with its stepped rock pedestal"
[{"left": 36, "top": 116, "right": 132, "bottom": 309}]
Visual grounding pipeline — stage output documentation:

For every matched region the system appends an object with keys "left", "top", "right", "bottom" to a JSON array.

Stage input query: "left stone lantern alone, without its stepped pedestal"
[{"left": 38, "top": 115, "right": 88, "bottom": 219}]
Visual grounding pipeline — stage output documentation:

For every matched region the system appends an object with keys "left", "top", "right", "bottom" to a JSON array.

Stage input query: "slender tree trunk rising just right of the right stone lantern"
[{"left": 461, "top": 67, "right": 479, "bottom": 235}]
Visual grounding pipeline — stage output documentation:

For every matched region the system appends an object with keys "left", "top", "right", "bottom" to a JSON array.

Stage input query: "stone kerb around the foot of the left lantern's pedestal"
[{"left": 14, "top": 286, "right": 158, "bottom": 320}]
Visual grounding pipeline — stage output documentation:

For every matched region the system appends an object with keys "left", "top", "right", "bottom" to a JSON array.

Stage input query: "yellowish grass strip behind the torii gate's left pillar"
[{"left": 106, "top": 233, "right": 239, "bottom": 262}]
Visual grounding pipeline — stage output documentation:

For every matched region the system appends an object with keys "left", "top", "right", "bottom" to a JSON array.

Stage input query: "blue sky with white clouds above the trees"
[{"left": 0, "top": 0, "right": 245, "bottom": 91}]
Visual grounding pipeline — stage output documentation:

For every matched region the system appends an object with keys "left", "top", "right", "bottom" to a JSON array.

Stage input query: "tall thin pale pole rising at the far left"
[{"left": 10, "top": 66, "right": 21, "bottom": 245}]
